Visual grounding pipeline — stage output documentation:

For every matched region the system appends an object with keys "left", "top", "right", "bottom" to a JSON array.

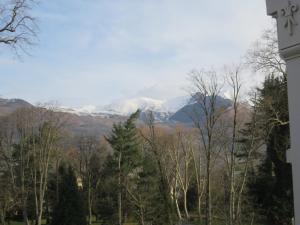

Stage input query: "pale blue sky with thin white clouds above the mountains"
[{"left": 0, "top": 0, "right": 272, "bottom": 107}]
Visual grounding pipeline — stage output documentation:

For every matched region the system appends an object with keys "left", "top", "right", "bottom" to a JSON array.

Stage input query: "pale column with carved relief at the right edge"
[{"left": 266, "top": 0, "right": 300, "bottom": 225}]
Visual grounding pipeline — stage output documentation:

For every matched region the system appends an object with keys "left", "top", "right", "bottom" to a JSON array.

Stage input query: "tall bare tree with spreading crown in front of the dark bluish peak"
[{"left": 190, "top": 70, "right": 226, "bottom": 225}]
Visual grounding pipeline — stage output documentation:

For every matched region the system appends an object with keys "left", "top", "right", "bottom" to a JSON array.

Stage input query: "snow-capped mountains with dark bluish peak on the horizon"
[{"left": 54, "top": 93, "right": 231, "bottom": 123}]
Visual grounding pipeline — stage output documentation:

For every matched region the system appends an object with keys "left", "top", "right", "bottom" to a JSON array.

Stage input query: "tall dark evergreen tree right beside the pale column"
[{"left": 250, "top": 76, "right": 293, "bottom": 225}]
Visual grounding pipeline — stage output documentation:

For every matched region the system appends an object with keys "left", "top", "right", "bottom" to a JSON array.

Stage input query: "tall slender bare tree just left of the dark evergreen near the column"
[{"left": 223, "top": 66, "right": 262, "bottom": 225}]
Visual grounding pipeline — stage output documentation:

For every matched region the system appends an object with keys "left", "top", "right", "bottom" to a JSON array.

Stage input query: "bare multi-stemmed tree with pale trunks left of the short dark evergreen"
[{"left": 26, "top": 108, "right": 62, "bottom": 225}]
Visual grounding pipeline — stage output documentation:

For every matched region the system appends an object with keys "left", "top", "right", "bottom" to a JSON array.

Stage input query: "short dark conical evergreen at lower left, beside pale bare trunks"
[{"left": 52, "top": 166, "right": 86, "bottom": 225}]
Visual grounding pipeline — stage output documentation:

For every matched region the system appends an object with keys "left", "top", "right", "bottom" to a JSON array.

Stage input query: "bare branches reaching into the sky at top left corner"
[{"left": 0, "top": 0, "right": 37, "bottom": 52}]
